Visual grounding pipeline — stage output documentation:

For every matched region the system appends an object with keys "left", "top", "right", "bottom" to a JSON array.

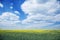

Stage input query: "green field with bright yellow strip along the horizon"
[{"left": 0, "top": 30, "right": 60, "bottom": 40}]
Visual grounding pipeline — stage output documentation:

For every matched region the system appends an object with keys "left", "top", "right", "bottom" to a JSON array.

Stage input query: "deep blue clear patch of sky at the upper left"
[{"left": 0, "top": 0, "right": 25, "bottom": 20}]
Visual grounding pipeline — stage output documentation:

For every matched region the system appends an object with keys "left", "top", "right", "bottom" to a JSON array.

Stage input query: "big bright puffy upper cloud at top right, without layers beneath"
[{"left": 22, "top": 0, "right": 59, "bottom": 15}]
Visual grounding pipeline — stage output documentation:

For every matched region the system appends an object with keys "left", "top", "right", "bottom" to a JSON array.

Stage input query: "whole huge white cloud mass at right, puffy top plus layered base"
[{"left": 21, "top": 0, "right": 60, "bottom": 28}]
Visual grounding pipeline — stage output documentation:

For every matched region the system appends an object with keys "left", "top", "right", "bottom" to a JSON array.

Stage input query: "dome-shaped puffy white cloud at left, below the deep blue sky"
[{"left": 0, "top": 12, "right": 19, "bottom": 21}]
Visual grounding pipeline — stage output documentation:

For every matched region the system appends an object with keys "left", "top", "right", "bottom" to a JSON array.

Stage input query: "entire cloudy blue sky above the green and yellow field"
[{"left": 0, "top": 0, "right": 60, "bottom": 30}]
